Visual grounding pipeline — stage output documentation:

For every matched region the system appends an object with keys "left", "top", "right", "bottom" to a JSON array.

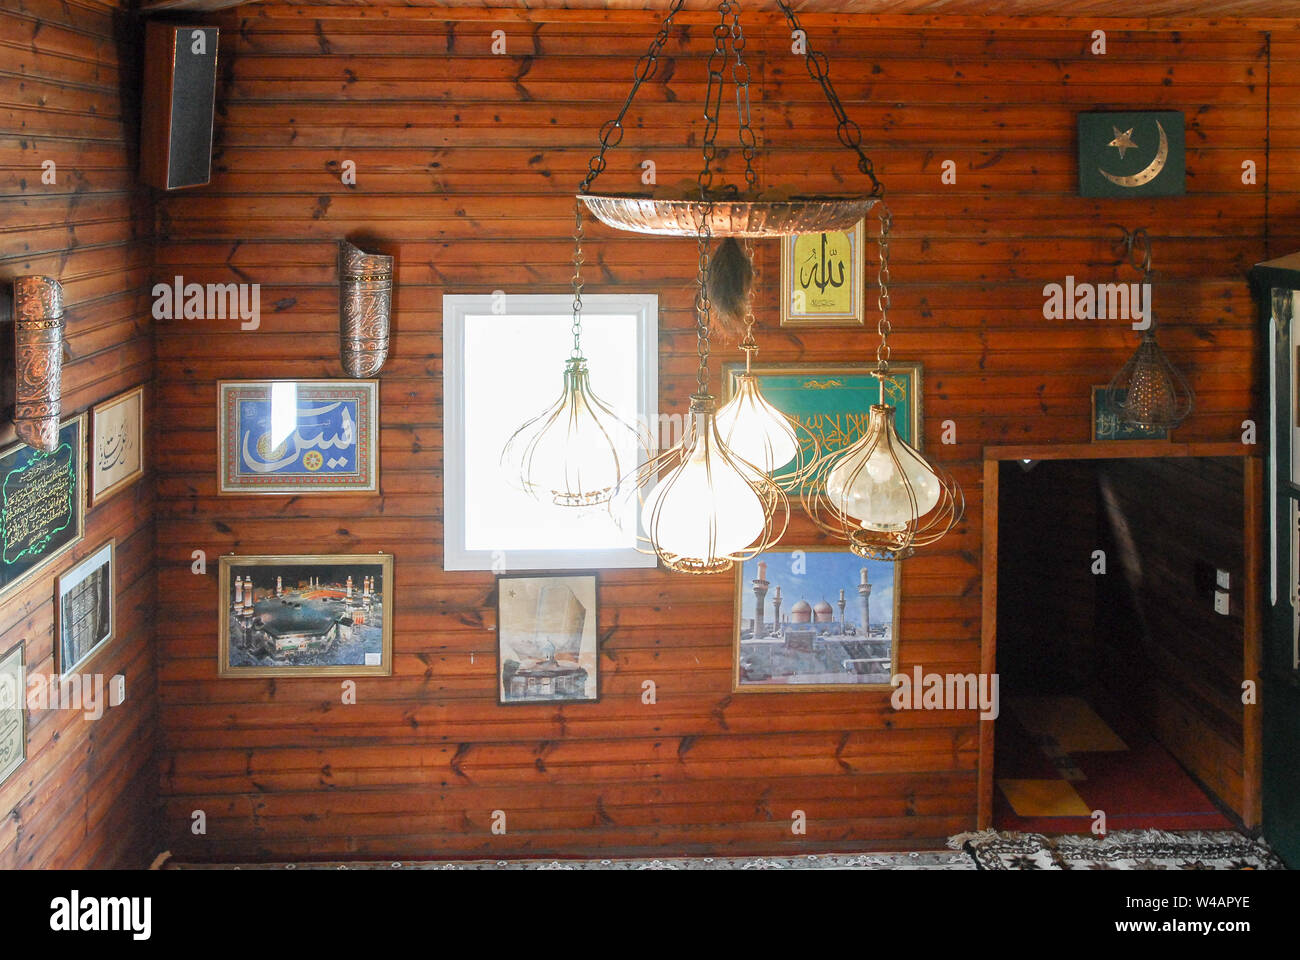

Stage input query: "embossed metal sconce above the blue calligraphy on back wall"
[{"left": 338, "top": 241, "right": 393, "bottom": 377}]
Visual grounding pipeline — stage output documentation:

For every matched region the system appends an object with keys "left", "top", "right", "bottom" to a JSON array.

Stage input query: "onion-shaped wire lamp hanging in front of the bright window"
[{"left": 501, "top": 356, "right": 645, "bottom": 507}]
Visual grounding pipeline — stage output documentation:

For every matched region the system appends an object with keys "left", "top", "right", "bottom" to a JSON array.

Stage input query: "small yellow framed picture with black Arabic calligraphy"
[{"left": 781, "top": 220, "right": 866, "bottom": 327}]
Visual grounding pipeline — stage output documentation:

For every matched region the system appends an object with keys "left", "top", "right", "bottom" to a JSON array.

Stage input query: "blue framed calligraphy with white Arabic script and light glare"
[{"left": 217, "top": 380, "right": 380, "bottom": 494}]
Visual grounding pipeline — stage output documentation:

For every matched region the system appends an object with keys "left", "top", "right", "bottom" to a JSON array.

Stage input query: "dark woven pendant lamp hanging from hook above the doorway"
[{"left": 1106, "top": 228, "right": 1196, "bottom": 434}]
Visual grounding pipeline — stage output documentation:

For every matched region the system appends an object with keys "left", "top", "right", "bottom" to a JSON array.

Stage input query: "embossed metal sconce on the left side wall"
[{"left": 13, "top": 277, "right": 64, "bottom": 453}]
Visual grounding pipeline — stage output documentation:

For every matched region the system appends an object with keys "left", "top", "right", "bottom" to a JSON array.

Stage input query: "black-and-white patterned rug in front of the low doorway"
[{"left": 948, "top": 830, "right": 1286, "bottom": 870}]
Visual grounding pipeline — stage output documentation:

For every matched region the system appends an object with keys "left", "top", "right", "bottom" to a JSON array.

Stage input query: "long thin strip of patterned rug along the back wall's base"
[{"left": 153, "top": 851, "right": 975, "bottom": 870}]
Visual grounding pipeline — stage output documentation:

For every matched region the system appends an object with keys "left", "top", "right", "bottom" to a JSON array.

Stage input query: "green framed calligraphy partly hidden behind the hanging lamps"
[{"left": 723, "top": 363, "right": 922, "bottom": 493}]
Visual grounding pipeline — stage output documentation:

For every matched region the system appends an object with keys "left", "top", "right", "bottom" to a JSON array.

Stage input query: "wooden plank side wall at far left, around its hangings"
[{"left": 0, "top": 0, "right": 157, "bottom": 868}]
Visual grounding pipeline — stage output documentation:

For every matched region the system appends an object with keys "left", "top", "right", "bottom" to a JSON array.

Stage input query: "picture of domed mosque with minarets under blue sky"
[{"left": 733, "top": 546, "right": 901, "bottom": 693}]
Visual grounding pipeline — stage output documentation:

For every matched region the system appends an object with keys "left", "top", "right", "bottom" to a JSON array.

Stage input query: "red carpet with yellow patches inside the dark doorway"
[{"left": 993, "top": 705, "right": 1234, "bottom": 834}]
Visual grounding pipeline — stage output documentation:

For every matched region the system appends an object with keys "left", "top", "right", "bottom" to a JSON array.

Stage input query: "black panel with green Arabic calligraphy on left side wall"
[{"left": 0, "top": 414, "right": 86, "bottom": 596}]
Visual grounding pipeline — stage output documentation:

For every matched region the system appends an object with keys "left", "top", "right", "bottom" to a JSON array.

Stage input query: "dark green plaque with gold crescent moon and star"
[{"left": 1079, "top": 111, "right": 1187, "bottom": 196}]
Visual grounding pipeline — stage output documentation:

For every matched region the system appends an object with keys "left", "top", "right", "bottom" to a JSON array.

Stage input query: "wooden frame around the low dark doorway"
[{"left": 976, "top": 440, "right": 1264, "bottom": 830}]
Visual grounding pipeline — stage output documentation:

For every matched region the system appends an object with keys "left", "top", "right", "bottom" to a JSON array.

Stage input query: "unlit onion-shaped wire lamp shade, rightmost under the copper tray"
[{"left": 806, "top": 403, "right": 965, "bottom": 559}]
